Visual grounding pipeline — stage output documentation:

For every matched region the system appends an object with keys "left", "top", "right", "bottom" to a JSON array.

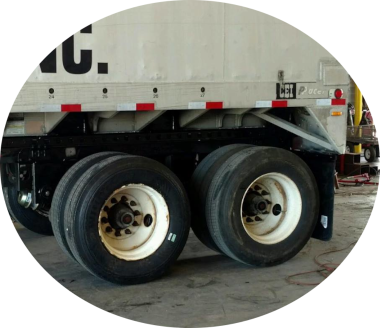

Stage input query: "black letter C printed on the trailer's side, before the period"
[{"left": 62, "top": 11, "right": 92, "bottom": 74}]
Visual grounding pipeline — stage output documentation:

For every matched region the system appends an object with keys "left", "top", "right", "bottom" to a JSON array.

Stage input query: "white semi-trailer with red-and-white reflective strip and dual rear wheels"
[{"left": 0, "top": 0, "right": 349, "bottom": 284}]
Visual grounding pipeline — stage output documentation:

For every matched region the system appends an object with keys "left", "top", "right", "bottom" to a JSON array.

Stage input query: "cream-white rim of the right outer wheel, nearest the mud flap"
[{"left": 241, "top": 173, "right": 302, "bottom": 245}]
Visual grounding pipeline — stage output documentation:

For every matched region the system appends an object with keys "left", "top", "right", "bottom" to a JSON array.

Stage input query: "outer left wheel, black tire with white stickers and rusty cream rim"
[{"left": 65, "top": 156, "right": 190, "bottom": 285}]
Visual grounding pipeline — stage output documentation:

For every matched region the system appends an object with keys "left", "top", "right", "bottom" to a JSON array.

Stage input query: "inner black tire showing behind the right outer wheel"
[{"left": 190, "top": 144, "right": 252, "bottom": 252}]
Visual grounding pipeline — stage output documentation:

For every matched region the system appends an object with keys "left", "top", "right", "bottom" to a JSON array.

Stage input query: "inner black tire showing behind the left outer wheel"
[{"left": 50, "top": 152, "right": 124, "bottom": 260}]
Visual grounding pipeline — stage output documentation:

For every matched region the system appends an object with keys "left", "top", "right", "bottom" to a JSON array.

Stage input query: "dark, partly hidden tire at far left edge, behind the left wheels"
[{"left": 3, "top": 187, "right": 53, "bottom": 236}]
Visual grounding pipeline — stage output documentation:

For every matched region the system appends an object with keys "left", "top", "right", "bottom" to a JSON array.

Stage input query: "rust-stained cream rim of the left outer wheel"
[{"left": 98, "top": 184, "right": 170, "bottom": 261}]
